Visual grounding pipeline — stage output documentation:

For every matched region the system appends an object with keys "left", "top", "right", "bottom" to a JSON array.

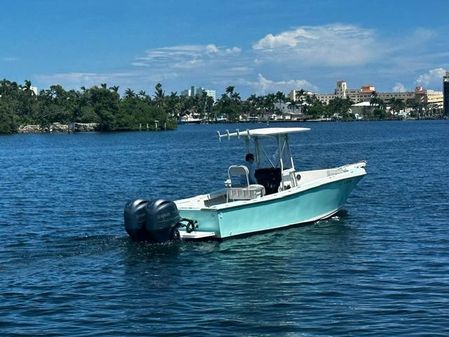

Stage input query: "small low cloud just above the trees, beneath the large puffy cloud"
[{"left": 239, "top": 74, "right": 317, "bottom": 95}]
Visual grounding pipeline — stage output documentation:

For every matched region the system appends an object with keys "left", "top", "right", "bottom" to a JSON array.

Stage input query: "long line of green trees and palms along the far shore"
[{"left": 0, "top": 79, "right": 440, "bottom": 133}]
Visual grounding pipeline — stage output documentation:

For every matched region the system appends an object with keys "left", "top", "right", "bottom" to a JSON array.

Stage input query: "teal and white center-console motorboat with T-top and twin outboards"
[{"left": 124, "top": 127, "right": 366, "bottom": 242}]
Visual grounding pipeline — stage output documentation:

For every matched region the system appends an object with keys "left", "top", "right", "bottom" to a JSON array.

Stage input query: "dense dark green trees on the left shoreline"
[{"left": 0, "top": 80, "right": 179, "bottom": 134}]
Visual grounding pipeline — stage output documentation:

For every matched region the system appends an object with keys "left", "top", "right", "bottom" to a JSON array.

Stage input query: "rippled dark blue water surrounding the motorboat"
[{"left": 0, "top": 121, "right": 449, "bottom": 336}]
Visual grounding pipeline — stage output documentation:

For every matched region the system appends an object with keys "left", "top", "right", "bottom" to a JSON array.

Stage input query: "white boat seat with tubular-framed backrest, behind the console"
[{"left": 225, "top": 165, "right": 265, "bottom": 201}]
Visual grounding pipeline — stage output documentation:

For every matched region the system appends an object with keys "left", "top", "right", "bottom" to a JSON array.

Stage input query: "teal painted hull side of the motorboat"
[{"left": 178, "top": 175, "right": 363, "bottom": 239}]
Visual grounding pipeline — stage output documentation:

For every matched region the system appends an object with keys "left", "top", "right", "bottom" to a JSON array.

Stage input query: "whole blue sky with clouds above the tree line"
[{"left": 0, "top": 0, "right": 449, "bottom": 97}]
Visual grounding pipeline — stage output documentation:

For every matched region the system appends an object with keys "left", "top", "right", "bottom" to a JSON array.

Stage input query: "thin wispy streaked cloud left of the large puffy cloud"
[{"left": 37, "top": 44, "right": 245, "bottom": 91}]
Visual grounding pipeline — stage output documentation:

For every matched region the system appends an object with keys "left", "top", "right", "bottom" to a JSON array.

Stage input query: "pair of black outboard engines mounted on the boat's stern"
[{"left": 124, "top": 199, "right": 181, "bottom": 243}]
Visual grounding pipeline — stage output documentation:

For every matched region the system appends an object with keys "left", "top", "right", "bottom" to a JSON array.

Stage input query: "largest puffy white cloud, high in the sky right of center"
[{"left": 253, "top": 24, "right": 378, "bottom": 66}]
